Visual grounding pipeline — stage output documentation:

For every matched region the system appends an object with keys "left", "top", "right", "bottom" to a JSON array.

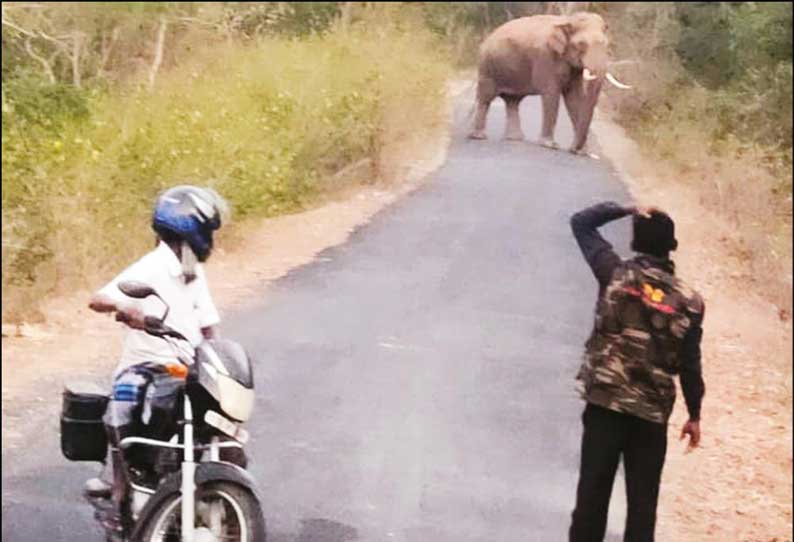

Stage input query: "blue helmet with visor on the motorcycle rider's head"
[{"left": 152, "top": 185, "right": 226, "bottom": 262}]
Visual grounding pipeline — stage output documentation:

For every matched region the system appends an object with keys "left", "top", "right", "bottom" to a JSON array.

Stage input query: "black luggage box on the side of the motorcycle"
[{"left": 61, "top": 382, "right": 110, "bottom": 461}]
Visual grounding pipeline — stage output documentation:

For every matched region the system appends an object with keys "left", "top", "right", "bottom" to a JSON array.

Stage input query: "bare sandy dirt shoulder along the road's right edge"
[{"left": 593, "top": 113, "right": 792, "bottom": 542}]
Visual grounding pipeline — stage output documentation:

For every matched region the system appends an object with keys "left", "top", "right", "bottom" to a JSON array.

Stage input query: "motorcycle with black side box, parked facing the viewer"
[{"left": 61, "top": 281, "right": 265, "bottom": 542}]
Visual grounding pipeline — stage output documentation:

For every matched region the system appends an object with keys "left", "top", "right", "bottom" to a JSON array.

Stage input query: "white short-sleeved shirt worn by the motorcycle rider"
[{"left": 99, "top": 241, "right": 220, "bottom": 374}]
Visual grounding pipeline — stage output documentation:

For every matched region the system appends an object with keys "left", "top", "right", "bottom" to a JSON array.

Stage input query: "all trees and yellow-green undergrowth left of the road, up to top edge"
[{"left": 2, "top": 3, "right": 448, "bottom": 318}]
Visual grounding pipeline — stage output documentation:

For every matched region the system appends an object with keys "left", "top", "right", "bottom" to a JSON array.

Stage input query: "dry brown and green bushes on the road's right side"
[{"left": 601, "top": 2, "right": 792, "bottom": 309}]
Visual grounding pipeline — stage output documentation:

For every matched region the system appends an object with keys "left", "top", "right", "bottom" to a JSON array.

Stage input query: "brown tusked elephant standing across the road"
[{"left": 469, "top": 12, "right": 631, "bottom": 154}]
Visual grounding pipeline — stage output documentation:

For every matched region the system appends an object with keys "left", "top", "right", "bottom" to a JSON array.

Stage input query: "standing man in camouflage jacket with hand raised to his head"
[{"left": 569, "top": 202, "right": 705, "bottom": 542}]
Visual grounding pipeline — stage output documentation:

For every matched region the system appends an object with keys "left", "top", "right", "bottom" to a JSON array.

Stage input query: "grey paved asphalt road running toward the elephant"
[{"left": 2, "top": 90, "right": 628, "bottom": 542}]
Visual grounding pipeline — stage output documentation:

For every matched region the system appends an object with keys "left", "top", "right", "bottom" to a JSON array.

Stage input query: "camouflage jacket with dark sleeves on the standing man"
[{"left": 572, "top": 204, "right": 704, "bottom": 423}]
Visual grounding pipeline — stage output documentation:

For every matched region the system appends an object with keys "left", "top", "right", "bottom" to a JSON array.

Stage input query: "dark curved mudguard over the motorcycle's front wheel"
[{"left": 130, "top": 461, "right": 261, "bottom": 542}]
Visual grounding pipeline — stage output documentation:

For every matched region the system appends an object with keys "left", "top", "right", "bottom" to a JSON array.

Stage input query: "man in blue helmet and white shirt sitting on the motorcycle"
[{"left": 85, "top": 185, "right": 228, "bottom": 531}]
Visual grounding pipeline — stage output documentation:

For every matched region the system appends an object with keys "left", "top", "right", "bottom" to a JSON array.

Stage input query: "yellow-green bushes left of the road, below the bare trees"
[{"left": 2, "top": 6, "right": 447, "bottom": 320}]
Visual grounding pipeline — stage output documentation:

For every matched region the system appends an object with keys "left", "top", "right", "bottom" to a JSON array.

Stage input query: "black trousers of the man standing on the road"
[{"left": 568, "top": 403, "right": 667, "bottom": 542}]
